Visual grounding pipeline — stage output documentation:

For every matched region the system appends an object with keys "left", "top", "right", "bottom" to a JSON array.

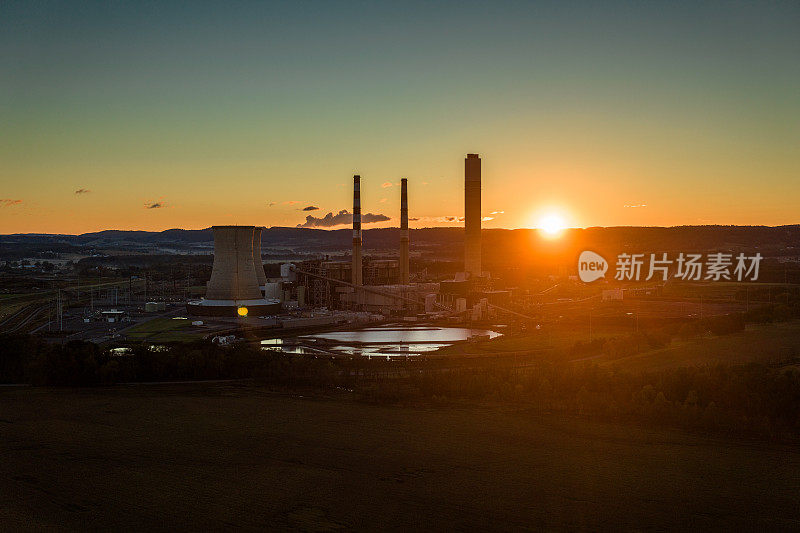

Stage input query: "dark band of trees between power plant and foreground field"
[{"left": 0, "top": 318, "right": 800, "bottom": 438}]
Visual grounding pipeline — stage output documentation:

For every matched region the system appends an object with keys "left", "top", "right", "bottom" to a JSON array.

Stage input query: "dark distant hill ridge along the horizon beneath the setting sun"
[{"left": 0, "top": 225, "right": 800, "bottom": 263}]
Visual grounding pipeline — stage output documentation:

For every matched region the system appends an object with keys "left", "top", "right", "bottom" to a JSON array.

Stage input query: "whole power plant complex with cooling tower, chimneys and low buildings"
[{"left": 188, "top": 154, "right": 507, "bottom": 316}]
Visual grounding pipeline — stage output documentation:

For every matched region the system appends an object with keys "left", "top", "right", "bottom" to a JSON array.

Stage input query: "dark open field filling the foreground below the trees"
[{"left": 0, "top": 384, "right": 800, "bottom": 530}]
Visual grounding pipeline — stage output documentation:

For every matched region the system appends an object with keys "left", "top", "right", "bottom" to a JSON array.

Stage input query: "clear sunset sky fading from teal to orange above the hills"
[{"left": 0, "top": 1, "right": 800, "bottom": 233}]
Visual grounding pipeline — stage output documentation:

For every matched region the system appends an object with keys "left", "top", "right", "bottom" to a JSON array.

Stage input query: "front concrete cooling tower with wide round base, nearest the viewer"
[{"left": 187, "top": 226, "right": 280, "bottom": 316}]
